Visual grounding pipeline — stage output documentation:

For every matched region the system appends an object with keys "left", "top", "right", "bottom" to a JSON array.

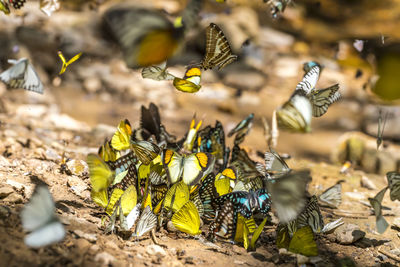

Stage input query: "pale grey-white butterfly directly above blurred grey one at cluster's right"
[{"left": 256, "top": 149, "right": 291, "bottom": 178}]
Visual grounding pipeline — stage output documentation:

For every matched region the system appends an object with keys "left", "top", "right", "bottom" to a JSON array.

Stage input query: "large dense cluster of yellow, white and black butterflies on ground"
[{"left": 74, "top": 104, "right": 342, "bottom": 255}]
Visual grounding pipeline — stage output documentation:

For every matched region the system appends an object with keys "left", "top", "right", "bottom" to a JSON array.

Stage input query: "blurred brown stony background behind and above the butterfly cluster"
[{"left": 0, "top": 0, "right": 400, "bottom": 170}]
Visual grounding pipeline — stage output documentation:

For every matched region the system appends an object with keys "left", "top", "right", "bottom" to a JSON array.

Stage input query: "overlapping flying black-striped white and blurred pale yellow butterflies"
[{"left": 276, "top": 61, "right": 341, "bottom": 133}]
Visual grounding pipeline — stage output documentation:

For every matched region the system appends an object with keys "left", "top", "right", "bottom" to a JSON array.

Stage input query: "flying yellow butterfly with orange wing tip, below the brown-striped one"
[{"left": 173, "top": 66, "right": 201, "bottom": 93}]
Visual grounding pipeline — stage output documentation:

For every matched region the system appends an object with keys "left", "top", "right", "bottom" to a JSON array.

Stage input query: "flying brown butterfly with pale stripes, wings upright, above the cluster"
[{"left": 201, "top": 23, "right": 237, "bottom": 70}]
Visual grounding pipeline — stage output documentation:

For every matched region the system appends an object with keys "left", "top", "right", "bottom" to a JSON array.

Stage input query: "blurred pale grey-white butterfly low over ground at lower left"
[{"left": 21, "top": 185, "right": 65, "bottom": 248}]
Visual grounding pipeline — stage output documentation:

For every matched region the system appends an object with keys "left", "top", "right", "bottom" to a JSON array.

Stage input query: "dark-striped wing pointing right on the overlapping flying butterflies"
[{"left": 308, "top": 84, "right": 341, "bottom": 117}]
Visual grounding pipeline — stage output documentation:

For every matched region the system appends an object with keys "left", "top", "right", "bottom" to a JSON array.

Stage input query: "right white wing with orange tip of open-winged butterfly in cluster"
[{"left": 182, "top": 152, "right": 215, "bottom": 185}]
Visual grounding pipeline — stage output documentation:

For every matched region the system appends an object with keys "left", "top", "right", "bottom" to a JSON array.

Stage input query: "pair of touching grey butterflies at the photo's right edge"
[{"left": 368, "top": 171, "right": 400, "bottom": 234}]
